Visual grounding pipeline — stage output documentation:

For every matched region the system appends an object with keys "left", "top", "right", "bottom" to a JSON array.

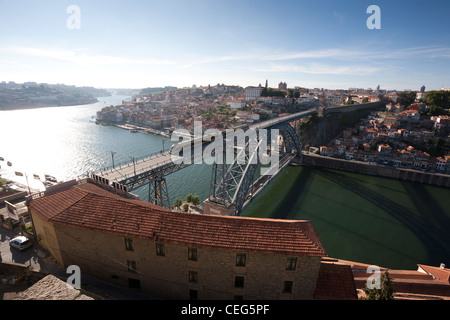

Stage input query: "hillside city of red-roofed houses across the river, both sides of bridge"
[{"left": 96, "top": 81, "right": 450, "bottom": 173}]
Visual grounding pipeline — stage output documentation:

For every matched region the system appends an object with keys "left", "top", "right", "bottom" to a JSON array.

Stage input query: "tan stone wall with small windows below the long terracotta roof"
[{"left": 30, "top": 212, "right": 321, "bottom": 300}]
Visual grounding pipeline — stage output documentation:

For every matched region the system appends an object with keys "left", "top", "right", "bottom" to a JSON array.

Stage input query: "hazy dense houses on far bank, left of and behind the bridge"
[{"left": 97, "top": 84, "right": 318, "bottom": 131}]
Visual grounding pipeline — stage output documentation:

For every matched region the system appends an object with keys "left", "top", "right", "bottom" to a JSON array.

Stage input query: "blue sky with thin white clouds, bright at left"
[{"left": 0, "top": 0, "right": 450, "bottom": 90}]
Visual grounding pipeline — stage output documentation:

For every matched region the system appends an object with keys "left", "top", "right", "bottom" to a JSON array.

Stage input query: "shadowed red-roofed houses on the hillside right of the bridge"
[{"left": 320, "top": 103, "right": 450, "bottom": 173}]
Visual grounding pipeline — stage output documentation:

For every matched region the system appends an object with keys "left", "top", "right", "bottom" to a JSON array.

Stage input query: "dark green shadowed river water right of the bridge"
[{"left": 242, "top": 166, "right": 450, "bottom": 270}]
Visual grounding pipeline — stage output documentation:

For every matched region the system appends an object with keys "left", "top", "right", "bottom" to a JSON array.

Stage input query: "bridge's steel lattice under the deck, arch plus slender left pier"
[{"left": 100, "top": 112, "right": 301, "bottom": 215}]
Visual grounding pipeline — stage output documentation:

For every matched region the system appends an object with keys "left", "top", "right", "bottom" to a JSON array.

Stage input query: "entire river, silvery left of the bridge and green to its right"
[{"left": 0, "top": 96, "right": 450, "bottom": 269}]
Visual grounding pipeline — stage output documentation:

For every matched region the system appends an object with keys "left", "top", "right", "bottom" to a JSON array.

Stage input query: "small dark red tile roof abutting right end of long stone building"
[{"left": 314, "top": 261, "right": 358, "bottom": 300}]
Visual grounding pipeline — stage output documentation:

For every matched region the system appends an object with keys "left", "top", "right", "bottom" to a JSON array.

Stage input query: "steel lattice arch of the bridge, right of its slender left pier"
[{"left": 209, "top": 122, "right": 302, "bottom": 215}]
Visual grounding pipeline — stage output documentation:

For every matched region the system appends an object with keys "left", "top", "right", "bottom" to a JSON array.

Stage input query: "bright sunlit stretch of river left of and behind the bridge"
[{"left": 0, "top": 96, "right": 211, "bottom": 200}]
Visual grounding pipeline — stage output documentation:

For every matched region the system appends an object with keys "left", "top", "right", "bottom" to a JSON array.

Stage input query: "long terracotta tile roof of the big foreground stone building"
[{"left": 29, "top": 183, "right": 326, "bottom": 256}]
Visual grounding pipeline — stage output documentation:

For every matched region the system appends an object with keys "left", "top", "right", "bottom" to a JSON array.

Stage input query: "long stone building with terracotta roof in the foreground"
[{"left": 28, "top": 180, "right": 326, "bottom": 300}]
